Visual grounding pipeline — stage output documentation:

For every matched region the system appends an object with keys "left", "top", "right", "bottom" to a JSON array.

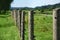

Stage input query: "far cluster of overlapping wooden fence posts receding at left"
[{"left": 11, "top": 10, "right": 25, "bottom": 40}]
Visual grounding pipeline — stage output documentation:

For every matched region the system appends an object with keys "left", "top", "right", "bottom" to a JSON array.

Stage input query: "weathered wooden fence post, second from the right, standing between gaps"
[{"left": 28, "top": 11, "right": 34, "bottom": 40}]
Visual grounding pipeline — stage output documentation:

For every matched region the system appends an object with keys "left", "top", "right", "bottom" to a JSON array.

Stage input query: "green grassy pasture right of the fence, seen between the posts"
[{"left": 25, "top": 14, "right": 53, "bottom": 40}]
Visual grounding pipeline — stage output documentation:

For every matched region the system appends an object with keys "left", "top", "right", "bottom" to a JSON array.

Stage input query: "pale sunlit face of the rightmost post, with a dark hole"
[{"left": 53, "top": 9, "right": 57, "bottom": 40}]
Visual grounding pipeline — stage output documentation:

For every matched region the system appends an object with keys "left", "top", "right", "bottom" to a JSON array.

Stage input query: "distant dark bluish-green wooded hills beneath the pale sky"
[{"left": 11, "top": 3, "right": 60, "bottom": 10}]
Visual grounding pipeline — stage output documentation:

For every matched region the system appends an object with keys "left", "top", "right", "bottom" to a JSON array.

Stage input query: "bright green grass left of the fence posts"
[{"left": 0, "top": 15, "right": 19, "bottom": 40}]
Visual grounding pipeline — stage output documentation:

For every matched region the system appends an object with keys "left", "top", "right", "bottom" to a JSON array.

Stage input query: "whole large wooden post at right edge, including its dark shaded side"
[{"left": 53, "top": 8, "right": 60, "bottom": 40}]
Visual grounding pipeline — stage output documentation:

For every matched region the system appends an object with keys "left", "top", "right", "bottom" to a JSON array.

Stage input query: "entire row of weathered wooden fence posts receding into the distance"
[{"left": 11, "top": 9, "right": 60, "bottom": 40}]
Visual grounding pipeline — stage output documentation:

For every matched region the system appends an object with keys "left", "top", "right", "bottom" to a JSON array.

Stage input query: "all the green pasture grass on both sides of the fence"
[{"left": 0, "top": 14, "right": 53, "bottom": 40}]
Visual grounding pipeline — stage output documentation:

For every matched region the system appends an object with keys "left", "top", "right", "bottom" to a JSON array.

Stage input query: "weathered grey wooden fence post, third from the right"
[{"left": 21, "top": 11, "right": 25, "bottom": 40}]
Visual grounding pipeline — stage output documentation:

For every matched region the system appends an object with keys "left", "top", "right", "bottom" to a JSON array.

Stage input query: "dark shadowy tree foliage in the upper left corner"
[{"left": 0, "top": 0, "right": 13, "bottom": 13}]
